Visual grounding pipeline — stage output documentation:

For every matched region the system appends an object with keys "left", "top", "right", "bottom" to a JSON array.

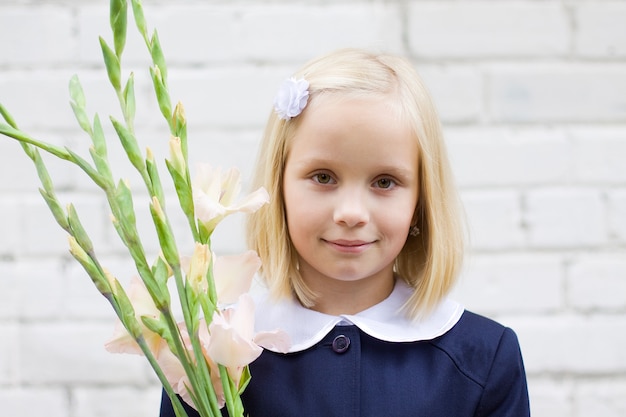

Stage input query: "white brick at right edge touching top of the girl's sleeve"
[{"left": 502, "top": 314, "right": 626, "bottom": 377}]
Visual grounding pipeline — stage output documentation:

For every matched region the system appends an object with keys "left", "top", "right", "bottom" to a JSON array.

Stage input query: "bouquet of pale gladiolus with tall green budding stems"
[{"left": 0, "top": 0, "right": 288, "bottom": 417}]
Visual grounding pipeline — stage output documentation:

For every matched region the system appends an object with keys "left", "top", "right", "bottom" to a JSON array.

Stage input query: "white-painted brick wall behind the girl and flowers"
[{"left": 0, "top": 0, "right": 626, "bottom": 417}]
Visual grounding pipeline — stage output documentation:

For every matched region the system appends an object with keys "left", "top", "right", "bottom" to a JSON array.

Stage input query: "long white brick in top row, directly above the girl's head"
[{"left": 162, "top": 2, "right": 402, "bottom": 62}]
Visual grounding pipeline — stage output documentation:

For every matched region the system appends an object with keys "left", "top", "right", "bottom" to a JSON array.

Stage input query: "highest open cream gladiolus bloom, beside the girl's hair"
[{"left": 192, "top": 164, "right": 269, "bottom": 233}]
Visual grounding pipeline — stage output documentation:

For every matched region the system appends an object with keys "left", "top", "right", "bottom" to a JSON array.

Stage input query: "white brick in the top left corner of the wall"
[{"left": 0, "top": 5, "right": 74, "bottom": 66}]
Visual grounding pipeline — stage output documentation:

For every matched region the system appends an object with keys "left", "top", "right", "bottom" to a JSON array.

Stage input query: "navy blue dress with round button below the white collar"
[{"left": 160, "top": 311, "right": 530, "bottom": 417}]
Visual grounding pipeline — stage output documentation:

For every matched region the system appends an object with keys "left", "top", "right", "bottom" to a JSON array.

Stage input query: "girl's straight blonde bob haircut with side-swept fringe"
[{"left": 246, "top": 49, "right": 465, "bottom": 320}]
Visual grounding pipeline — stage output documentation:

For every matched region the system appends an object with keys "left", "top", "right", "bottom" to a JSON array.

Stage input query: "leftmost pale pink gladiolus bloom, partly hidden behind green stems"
[{"left": 104, "top": 276, "right": 161, "bottom": 355}]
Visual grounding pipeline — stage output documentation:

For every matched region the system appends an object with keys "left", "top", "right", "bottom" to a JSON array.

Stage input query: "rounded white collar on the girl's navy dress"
[{"left": 250, "top": 280, "right": 464, "bottom": 352}]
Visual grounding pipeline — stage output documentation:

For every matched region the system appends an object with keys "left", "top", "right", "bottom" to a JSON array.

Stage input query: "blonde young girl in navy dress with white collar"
[{"left": 161, "top": 50, "right": 530, "bottom": 417}]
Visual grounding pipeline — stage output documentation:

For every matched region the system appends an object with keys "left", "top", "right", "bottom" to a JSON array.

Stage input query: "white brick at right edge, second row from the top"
[{"left": 488, "top": 63, "right": 626, "bottom": 123}]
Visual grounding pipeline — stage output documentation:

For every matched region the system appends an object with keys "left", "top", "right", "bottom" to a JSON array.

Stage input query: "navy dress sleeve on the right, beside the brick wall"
[{"left": 476, "top": 328, "right": 530, "bottom": 417}]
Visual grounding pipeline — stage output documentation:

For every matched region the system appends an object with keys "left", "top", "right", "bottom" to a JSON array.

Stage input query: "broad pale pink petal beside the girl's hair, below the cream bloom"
[{"left": 213, "top": 251, "right": 261, "bottom": 305}]
